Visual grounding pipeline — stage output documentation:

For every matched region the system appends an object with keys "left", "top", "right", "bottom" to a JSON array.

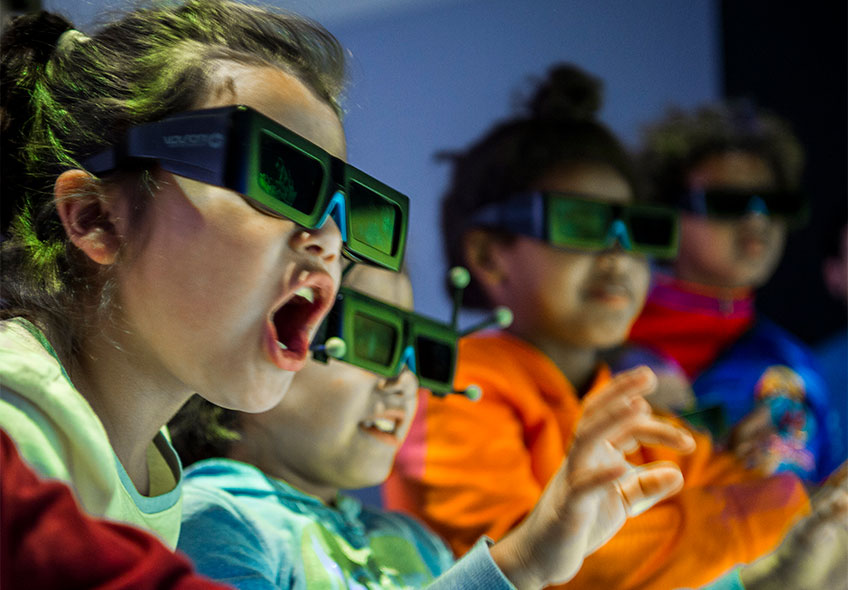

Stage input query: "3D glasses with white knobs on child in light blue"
[{"left": 313, "top": 287, "right": 460, "bottom": 395}]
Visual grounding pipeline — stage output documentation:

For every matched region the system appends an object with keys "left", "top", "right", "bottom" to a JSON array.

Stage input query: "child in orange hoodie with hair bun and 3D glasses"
[{"left": 385, "top": 65, "right": 808, "bottom": 589}]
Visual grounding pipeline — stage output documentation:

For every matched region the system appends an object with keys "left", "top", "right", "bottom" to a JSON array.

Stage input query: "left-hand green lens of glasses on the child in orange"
[{"left": 548, "top": 197, "right": 612, "bottom": 249}]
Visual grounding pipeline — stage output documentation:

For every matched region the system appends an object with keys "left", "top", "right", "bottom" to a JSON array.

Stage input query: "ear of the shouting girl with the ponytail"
[{"left": 53, "top": 170, "right": 121, "bottom": 265}]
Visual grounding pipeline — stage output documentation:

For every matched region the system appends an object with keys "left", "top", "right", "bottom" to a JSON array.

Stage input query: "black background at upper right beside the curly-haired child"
[{"left": 721, "top": 0, "right": 848, "bottom": 343}]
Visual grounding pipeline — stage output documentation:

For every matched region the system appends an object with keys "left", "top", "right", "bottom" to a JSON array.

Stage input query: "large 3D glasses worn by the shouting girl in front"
[{"left": 84, "top": 106, "right": 409, "bottom": 270}]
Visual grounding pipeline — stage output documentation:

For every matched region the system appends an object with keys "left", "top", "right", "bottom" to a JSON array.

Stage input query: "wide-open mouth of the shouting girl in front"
[{"left": 267, "top": 277, "right": 331, "bottom": 371}]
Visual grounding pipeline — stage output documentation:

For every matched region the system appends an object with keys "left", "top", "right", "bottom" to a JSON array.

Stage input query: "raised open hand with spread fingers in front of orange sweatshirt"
[{"left": 492, "top": 367, "right": 695, "bottom": 589}]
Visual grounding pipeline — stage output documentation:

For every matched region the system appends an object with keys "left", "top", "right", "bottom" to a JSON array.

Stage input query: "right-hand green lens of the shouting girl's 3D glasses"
[{"left": 348, "top": 180, "right": 401, "bottom": 256}]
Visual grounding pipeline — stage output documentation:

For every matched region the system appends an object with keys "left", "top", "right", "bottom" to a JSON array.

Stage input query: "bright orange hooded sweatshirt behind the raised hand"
[{"left": 384, "top": 333, "right": 809, "bottom": 590}]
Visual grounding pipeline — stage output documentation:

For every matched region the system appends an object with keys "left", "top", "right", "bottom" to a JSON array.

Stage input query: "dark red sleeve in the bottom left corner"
[{"left": 0, "top": 431, "right": 232, "bottom": 590}]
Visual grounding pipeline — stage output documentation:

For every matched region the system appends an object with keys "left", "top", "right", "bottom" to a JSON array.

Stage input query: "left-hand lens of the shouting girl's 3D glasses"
[{"left": 257, "top": 130, "right": 324, "bottom": 223}]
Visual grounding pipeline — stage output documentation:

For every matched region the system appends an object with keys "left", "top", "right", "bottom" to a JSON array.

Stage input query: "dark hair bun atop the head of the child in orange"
[{"left": 527, "top": 63, "right": 603, "bottom": 121}]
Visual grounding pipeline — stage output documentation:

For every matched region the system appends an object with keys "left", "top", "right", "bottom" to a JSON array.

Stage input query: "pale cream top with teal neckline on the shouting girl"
[{"left": 0, "top": 318, "right": 182, "bottom": 548}]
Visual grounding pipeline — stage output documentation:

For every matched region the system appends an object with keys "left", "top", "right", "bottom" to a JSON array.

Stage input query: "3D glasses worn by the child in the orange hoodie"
[{"left": 470, "top": 192, "right": 680, "bottom": 258}]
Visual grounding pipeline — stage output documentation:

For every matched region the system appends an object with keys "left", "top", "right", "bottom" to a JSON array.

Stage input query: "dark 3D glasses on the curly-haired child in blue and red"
[{"left": 680, "top": 188, "right": 809, "bottom": 224}]
